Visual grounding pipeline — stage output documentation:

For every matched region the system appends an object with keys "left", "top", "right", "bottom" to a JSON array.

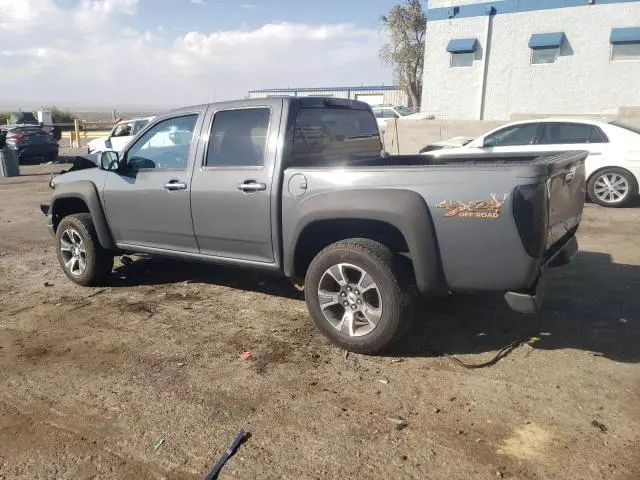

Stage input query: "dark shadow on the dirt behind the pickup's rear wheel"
[{"left": 392, "top": 252, "right": 640, "bottom": 363}]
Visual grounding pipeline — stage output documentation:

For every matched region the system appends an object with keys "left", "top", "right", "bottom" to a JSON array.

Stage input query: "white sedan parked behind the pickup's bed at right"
[{"left": 422, "top": 118, "right": 640, "bottom": 207}]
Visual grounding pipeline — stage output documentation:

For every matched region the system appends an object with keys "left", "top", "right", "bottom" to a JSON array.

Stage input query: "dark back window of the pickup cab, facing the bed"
[{"left": 291, "top": 108, "right": 382, "bottom": 165}]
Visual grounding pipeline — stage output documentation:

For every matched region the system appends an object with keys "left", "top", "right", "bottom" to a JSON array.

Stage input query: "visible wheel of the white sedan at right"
[{"left": 587, "top": 167, "right": 638, "bottom": 208}]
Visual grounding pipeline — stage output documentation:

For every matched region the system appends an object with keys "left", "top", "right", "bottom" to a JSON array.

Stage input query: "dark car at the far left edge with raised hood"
[{"left": 0, "top": 125, "right": 58, "bottom": 164}]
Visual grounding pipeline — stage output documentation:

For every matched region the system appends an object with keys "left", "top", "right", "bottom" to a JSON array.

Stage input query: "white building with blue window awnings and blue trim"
[{"left": 422, "top": 0, "right": 640, "bottom": 120}]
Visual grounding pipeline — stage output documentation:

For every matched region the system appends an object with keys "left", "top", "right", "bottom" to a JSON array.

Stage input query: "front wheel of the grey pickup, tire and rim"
[{"left": 56, "top": 213, "right": 113, "bottom": 287}]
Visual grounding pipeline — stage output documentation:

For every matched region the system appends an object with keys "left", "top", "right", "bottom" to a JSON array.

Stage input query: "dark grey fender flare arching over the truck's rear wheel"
[{"left": 284, "top": 189, "right": 445, "bottom": 292}]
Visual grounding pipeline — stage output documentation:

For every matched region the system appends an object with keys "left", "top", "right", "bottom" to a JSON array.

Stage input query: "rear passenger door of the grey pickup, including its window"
[{"left": 191, "top": 99, "right": 282, "bottom": 263}]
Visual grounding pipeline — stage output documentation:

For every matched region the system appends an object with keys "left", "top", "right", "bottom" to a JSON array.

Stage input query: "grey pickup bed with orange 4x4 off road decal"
[{"left": 282, "top": 152, "right": 586, "bottom": 291}]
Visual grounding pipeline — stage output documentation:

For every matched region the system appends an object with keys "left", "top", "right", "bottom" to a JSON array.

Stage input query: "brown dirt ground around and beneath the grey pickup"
[{"left": 0, "top": 154, "right": 640, "bottom": 480}]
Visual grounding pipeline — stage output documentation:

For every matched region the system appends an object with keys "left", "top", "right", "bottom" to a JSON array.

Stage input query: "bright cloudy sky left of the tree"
[{"left": 0, "top": 0, "right": 401, "bottom": 108}]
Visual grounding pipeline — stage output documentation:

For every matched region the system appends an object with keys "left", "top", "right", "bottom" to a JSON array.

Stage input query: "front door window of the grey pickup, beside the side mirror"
[{"left": 127, "top": 115, "right": 198, "bottom": 170}]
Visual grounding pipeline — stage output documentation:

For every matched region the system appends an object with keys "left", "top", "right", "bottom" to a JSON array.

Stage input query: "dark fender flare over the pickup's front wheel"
[{"left": 51, "top": 180, "right": 117, "bottom": 250}]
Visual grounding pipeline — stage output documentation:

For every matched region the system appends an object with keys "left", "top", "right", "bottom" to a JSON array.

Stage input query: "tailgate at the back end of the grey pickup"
[{"left": 539, "top": 152, "right": 588, "bottom": 250}]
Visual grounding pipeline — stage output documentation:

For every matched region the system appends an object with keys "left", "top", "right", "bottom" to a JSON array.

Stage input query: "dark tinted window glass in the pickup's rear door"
[{"left": 205, "top": 108, "right": 271, "bottom": 167}]
